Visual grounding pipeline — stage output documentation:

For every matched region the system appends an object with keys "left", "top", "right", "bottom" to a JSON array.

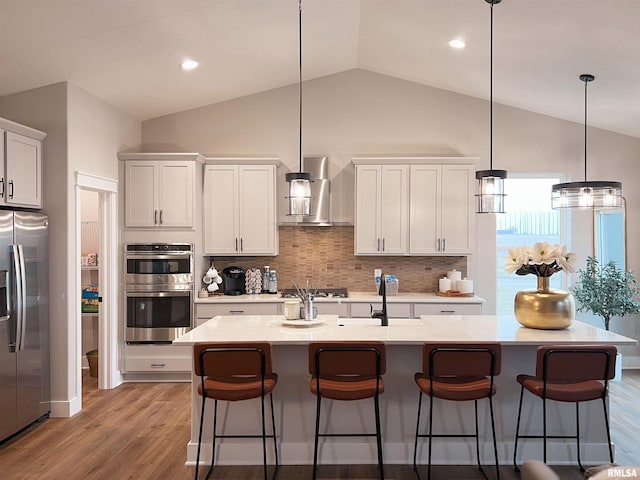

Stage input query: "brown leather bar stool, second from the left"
[{"left": 309, "top": 342, "right": 386, "bottom": 480}]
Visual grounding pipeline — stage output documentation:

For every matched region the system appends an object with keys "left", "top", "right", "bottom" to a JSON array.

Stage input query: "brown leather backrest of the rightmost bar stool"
[{"left": 536, "top": 345, "right": 618, "bottom": 382}]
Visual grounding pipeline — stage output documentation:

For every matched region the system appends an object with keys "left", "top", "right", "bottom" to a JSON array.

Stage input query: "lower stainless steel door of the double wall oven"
[{"left": 125, "top": 289, "right": 193, "bottom": 343}]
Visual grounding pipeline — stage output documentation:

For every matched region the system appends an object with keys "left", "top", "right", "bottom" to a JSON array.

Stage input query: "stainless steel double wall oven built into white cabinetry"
[{"left": 124, "top": 243, "right": 194, "bottom": 343}]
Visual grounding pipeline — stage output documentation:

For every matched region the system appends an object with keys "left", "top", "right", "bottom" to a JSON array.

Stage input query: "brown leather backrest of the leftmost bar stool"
[{"left": 193, "top": 342, "right": 272, "bottom": 377}]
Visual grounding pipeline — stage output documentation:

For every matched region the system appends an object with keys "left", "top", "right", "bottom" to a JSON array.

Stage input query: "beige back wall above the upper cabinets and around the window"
[{"left": 142, "top": 70, "right": 640, "bottom": 364}]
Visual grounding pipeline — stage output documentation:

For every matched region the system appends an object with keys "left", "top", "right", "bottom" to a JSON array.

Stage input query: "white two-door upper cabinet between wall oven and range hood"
[{"left": 203, "top": 162, "right": 278, "bottom": 255}]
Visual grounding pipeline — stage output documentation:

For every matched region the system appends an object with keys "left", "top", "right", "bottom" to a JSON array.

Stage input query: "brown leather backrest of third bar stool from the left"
[{"left": 422, "top": 342, "right": 502, "bottom": 377}]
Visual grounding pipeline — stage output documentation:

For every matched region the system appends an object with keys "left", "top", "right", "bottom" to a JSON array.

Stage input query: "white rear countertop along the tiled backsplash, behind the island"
[{"left": 195, "top": 292, "right": 485, "bottom": 304}]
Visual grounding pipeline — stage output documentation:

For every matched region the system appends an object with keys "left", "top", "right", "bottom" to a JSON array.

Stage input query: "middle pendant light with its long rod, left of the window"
[{"left": 476, "top": 0, "right": 507, "bottom": 213}]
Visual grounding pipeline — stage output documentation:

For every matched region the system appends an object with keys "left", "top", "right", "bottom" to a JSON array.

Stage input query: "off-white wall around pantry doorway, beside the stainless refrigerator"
[{"left": 0, "top": 83, "right": 141, "bottom": 416}]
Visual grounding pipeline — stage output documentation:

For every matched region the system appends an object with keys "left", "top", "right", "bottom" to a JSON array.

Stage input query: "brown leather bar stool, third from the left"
[{"left": 413, "top": 342, "right": 502, "bottom": 480}]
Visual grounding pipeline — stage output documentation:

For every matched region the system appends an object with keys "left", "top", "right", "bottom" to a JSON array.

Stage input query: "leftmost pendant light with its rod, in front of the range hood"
[{"left": 285, "top": 0, "right": 311, "bottom": 216}]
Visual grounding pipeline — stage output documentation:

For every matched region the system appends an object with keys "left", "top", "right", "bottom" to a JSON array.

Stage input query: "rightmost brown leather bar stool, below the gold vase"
[{"left": 513, "top": 345, "right": 617, "bottom": 471}]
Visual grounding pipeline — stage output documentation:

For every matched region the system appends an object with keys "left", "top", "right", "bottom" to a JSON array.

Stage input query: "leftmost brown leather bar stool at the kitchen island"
[{"left": 193, "top": 342, "right": 278, "bottom": 480}]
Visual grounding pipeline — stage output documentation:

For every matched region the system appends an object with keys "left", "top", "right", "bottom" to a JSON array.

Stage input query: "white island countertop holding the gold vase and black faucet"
[{"left": 173, "top": 315, "right": 637, "bottom": 345}]
